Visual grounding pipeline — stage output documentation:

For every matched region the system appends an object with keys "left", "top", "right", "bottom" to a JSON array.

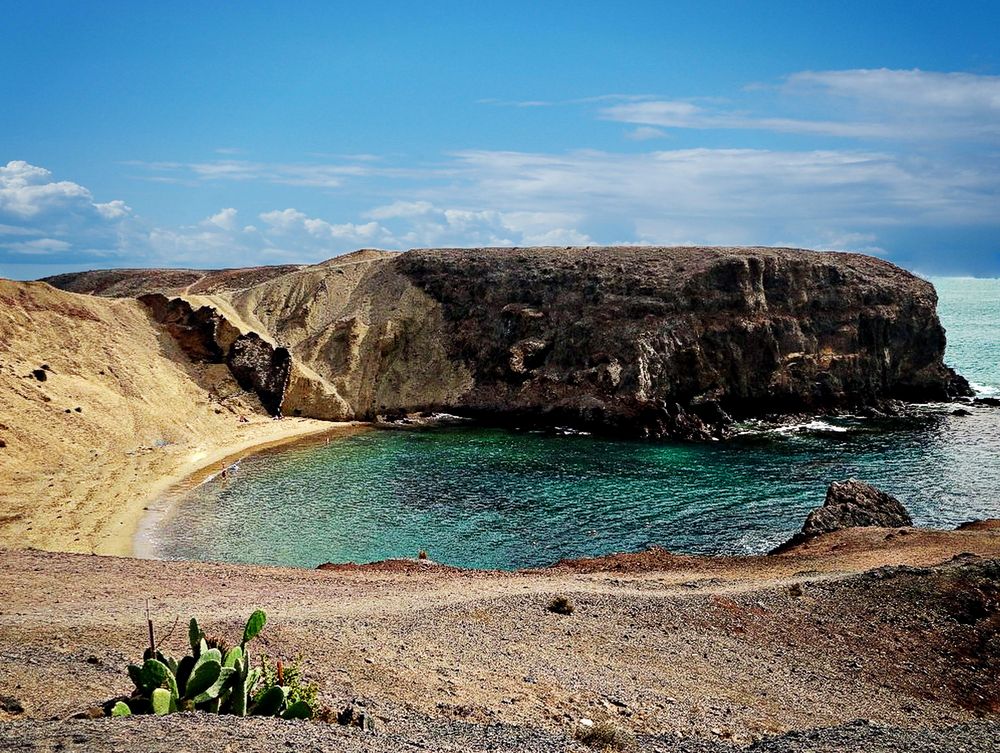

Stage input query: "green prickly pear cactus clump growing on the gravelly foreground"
[{"left": 110, "top": 609, "right": 316, "bottom": 719}]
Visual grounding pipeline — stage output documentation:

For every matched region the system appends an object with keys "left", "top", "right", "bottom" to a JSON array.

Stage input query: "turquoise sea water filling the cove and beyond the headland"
[{"left": 151, "top": 278, "right": 1000, "bottom": 568}]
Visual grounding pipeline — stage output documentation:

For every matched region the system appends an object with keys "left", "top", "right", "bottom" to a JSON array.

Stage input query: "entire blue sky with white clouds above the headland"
[{"left": 0, "top": 0, "right": 1000, "bottom": 279}]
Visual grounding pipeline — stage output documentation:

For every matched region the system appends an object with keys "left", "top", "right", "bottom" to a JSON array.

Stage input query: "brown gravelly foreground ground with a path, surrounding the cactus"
[{"left": 0, "top": 524, "right": 1000, "bottom": 751}]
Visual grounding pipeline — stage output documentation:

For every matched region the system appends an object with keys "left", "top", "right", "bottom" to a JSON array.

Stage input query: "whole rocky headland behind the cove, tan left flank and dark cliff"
[{"left": 41, "top": 247, "right": 968, "bottom": 438}]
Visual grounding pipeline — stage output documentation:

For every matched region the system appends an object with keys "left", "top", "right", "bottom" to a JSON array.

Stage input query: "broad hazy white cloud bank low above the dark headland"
[{"left": 442, "top": 149, "right": 1000, "bottom": 250}]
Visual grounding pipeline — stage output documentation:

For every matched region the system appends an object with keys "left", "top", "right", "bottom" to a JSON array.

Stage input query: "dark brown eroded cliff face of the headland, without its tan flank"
[{"left": 394, "top": 248, "right": 963, "bottom": 436}]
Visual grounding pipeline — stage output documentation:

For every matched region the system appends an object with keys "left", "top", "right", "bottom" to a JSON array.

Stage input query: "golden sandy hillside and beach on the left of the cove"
[{"left": 0, "top": 280, "right": 352, "bottom": 554}]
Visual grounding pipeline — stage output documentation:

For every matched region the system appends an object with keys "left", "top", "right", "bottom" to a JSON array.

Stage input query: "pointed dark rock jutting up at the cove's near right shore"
[{"left": 770, "top": 478, "right": 913, "bottom": 554}]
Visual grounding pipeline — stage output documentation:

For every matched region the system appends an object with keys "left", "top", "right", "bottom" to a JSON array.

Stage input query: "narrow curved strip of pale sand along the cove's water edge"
[{"left": 131, "top": 418, "right": 371, "bottom": 560}]
